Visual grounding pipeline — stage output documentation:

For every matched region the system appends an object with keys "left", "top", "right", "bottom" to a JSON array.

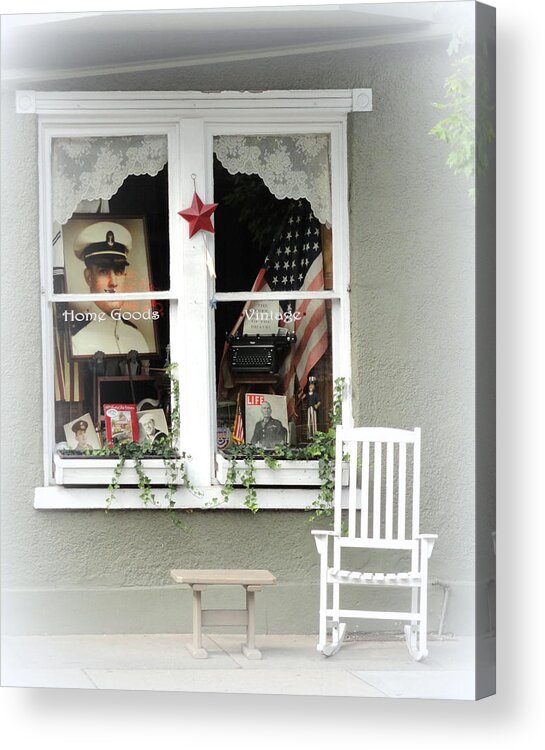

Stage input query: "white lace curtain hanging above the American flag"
[{"left": 214, "top": 135, "right": 331, "bottom": 226}]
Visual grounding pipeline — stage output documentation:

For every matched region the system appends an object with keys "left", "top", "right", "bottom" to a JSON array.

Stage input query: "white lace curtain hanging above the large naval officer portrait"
[{"left": 52, "top": 135, "right": 168, "bottom": 224}]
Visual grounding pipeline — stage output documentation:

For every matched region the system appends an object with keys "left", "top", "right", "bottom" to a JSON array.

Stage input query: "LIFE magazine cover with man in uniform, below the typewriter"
[{"left": 245, "top": 393, "right": 288, "bottom": 448}]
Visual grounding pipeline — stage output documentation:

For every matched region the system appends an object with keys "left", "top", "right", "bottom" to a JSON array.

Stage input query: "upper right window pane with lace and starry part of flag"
[{"left": 214, "top": 135, "right": 333, "bottom": 292}]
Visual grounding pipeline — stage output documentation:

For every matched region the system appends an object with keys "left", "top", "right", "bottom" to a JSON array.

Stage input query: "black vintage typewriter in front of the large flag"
[{"left": 227, "top": 333, "right": 296, "bottom": 374}]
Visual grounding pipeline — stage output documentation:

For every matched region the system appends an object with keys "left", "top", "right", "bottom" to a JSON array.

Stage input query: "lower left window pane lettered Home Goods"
[{"left": 53, "top": 300, "right": 170, "bottom": 448}]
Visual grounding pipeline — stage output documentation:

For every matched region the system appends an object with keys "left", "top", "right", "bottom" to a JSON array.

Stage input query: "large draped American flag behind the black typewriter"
[{"left": 220, "top": 200, "right": 328, "bottom": 417}]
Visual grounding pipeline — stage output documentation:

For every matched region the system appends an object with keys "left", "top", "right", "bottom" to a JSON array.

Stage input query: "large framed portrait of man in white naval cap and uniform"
[{"left": 62, "top": 214, "right": 159, "bottom": 358}]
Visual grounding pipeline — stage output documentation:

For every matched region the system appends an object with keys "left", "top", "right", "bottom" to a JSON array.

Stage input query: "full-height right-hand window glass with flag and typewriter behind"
[{"left": 214, "top": 133, "right": 334, "bottom": 448}]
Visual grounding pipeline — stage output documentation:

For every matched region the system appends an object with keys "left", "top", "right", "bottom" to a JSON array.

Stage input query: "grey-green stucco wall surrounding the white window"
[{"left": 1, "top": 41, "right": 475, "bottom": 633}]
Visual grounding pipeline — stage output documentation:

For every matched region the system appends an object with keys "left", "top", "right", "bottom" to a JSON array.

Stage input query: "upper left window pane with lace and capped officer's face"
[{"left": 53, "top": 136, "right": 170, "bottom": 294}]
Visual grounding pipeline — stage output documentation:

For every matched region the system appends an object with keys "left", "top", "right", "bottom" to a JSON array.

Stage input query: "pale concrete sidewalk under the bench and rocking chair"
[{"left": 2, "top": 634, "right": 484, "bottom": 700}]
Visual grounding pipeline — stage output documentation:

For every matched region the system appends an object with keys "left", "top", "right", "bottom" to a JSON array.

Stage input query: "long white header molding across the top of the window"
[{"left": 16, "top": 89, "right": 373, "bottom": 117}]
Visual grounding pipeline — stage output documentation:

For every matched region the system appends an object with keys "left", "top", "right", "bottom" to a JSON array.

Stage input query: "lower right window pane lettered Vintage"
[{"left": 216, "top": 299, "right": 333, "bottom": 449}]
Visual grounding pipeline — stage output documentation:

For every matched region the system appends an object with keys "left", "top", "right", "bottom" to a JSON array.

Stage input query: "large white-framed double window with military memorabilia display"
[{"left": 18, "top": 90, "right": 370, "bottom": 507}]
